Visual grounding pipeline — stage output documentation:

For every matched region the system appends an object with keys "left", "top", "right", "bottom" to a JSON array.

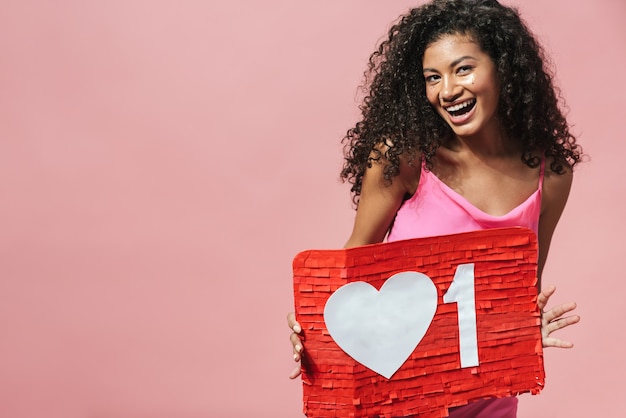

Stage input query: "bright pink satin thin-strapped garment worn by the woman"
[{"left": 387, "top": 159, "right": 545, "bottom": 418}]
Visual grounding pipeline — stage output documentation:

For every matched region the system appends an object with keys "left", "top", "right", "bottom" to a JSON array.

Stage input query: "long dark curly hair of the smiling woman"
[{"left": 341, "top": 0, "right": 582, "bottom": 204}]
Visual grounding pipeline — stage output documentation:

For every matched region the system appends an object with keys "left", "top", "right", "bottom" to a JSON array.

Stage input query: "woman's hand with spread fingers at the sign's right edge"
[{"left": 537, "top": 286, "right": 580, "bottom": 348}]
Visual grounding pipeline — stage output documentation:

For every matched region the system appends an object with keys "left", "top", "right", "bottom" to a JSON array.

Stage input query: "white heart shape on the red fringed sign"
[{"left": 324, "top": 271, "right": 437, "bottom": 379}]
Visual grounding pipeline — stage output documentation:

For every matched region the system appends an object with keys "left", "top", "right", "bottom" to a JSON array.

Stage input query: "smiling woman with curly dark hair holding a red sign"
[{"left": 289, "top": 0, "right": 582, "bottom": 418}]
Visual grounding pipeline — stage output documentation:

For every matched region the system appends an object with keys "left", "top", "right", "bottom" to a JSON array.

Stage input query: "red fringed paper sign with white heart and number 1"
[{"left": 293, "top": 228, "right": 545, "bottom": 418}]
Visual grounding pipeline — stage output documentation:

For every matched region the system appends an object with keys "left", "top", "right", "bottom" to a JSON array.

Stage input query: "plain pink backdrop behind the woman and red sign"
[{"left": 0, "top": 0, "right": 626, "bottom": 418}]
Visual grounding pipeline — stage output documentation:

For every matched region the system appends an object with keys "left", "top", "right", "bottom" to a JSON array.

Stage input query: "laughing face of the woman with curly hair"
[{"left": 422, "top": 34, "right": 500, "bottom": 138}]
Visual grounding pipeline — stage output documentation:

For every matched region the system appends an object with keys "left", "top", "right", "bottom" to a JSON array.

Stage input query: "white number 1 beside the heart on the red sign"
[{"left": 443, "top": 263, "right": 479, "bottom": 367}]
